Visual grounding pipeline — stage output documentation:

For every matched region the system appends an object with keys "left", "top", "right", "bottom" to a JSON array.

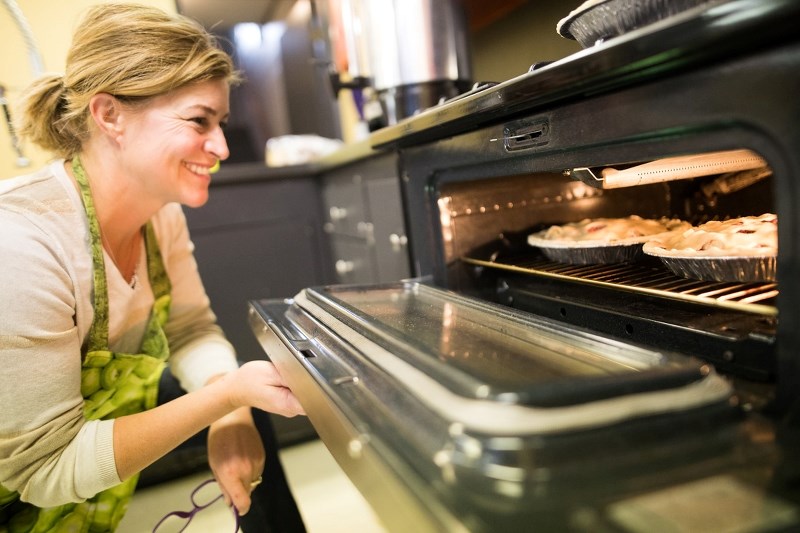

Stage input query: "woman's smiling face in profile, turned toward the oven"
[{"left": 118, "top": 80, "right": 230, "bottom": 207}]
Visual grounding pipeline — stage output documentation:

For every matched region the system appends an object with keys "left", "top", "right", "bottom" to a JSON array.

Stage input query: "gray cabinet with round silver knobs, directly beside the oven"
[{"left": 322, "top": 153, "right": 411, "bottom": 283}]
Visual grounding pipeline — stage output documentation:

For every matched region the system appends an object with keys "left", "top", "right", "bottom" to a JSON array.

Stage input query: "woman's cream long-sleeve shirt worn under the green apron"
[{"left": 0, "top": 160, "right": 237, "bottom": 507}]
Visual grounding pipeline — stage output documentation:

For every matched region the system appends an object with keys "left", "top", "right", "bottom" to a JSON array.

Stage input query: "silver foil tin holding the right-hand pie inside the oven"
[{"left": 642, "top": 242, "right": 778, "bottom": 283}]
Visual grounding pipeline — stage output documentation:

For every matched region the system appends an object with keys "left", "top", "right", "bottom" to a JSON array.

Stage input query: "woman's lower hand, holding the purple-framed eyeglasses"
[{"left": 208, "top": 407, "right": 264, "bottom": 515}]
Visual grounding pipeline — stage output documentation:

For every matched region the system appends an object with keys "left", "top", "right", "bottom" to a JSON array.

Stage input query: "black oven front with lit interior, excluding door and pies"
[{"left": 401, "top": 33, "right": 800, "bottom": 407}]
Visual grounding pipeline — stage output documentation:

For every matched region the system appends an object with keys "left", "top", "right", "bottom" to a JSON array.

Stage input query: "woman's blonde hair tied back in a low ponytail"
[{"left": 19, "top": 3, "right": 239, "bottom": 158}]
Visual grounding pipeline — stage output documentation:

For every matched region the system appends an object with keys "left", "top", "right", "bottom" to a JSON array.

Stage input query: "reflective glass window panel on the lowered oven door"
[{"left": 308, "top": 283, "right": 702, "bottom": 401}]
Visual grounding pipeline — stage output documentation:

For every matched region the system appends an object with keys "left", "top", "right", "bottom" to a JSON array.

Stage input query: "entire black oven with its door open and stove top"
[{"left": 250, "top": 1, "right": 800, "bottom": 532}]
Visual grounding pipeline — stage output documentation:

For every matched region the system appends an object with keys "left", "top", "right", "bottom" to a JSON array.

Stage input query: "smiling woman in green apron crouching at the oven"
[{"left": 0, "top": 4, "right": 303, "bottom": 532}]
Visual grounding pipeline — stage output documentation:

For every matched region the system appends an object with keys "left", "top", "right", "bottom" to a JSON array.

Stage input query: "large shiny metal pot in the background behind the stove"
[{"left": 328, "top": 0, "right": 472, "bottom": 124}]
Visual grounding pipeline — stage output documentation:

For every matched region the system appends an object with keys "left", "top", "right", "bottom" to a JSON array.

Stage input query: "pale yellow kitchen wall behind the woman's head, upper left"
[{"left": 0, "top": 0, "right": 176, "bottom": 178}]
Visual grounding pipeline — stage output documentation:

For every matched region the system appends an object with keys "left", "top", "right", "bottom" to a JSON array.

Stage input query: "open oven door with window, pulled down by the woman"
[{"left": 250, "top": 280, "right": 798, "bottom": 532}]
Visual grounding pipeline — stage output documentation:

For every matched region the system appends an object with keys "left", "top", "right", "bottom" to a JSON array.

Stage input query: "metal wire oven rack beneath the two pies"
[{"left": 461, "top": 256, "right": 778, "bottom": 316}]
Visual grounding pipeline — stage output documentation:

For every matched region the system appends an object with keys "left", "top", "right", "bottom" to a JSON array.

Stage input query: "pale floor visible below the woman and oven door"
[{"left": 117, "top": 440, "right": 386, "bottom": 533}]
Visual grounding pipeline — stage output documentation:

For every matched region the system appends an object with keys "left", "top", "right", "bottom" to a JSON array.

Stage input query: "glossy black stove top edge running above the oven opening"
[{"left": 369, "top": 0, "right": 800, "bottom": 148}]
